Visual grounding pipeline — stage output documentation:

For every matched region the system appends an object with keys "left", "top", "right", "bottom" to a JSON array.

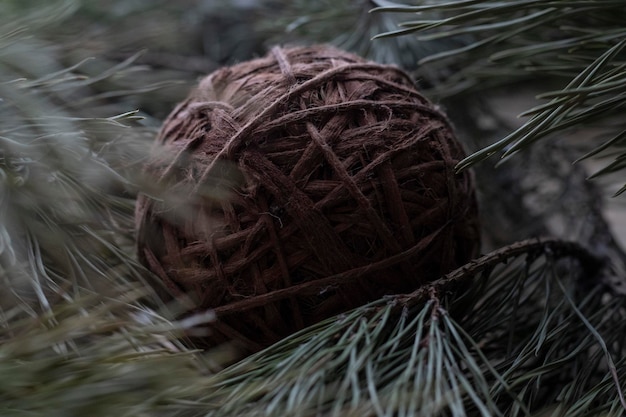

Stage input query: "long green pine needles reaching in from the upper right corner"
[{"left": 374, "top": 0, "right": 626, "bottom": 186}]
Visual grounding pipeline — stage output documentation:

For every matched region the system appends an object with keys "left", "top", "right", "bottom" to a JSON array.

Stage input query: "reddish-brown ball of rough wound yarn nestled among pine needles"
[{"left": 136, "top": 46, "right": 480, "bottom": 351}]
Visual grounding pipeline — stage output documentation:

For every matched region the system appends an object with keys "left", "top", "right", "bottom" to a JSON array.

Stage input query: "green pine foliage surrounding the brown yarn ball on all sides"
[{"left": 0, "top": 0, "right": 626, "bottom": 417}]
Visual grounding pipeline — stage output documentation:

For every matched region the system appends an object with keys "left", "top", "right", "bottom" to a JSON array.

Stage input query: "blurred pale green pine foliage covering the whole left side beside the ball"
[{"left": 0, "top": 1, "right": 224, "bottom": 417}]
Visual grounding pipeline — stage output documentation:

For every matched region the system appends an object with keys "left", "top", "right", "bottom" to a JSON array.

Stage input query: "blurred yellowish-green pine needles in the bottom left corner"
[{"left": 0, "top": 287, "right": 210, "bottom": 417}]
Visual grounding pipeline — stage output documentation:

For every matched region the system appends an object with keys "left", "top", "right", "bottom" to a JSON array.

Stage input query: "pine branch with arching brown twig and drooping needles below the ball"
[{"left": 203, "top": 239, "right": 626, "bottom": 416}]
